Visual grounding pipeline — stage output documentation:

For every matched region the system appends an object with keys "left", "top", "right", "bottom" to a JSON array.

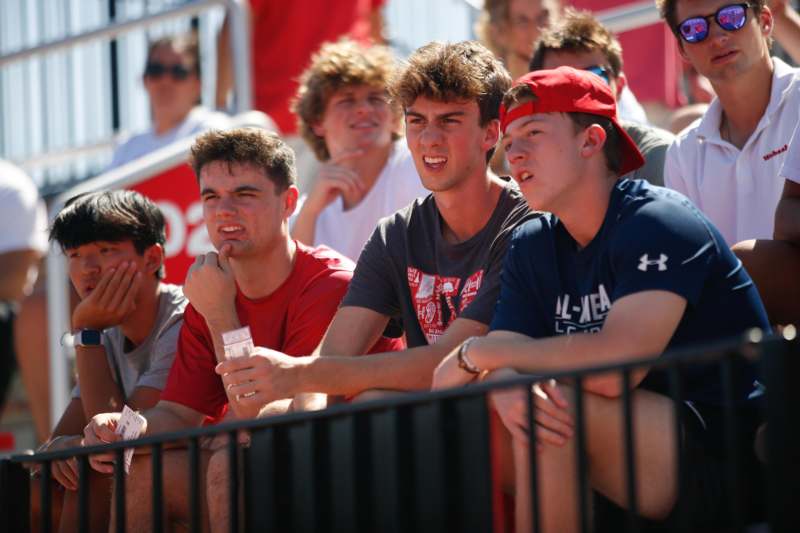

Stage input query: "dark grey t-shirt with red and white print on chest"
[{"left": 342, "top": 185, "right": 533, "bottom": 347}]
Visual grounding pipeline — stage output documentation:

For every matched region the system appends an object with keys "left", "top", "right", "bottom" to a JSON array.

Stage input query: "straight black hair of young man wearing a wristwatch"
[{"left": 50, "top": 190, "right": 167, "bottom": 279}]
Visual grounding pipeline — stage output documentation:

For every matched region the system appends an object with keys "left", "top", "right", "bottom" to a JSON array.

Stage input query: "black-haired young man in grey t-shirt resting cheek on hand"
[{"left": 31, "top": 191, "right": 186, "bottom": 531}]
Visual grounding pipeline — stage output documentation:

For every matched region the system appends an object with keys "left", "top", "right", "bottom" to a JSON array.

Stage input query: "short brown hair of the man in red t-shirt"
[{"left": 189, "top": 128, "right": 297, "bottom": 194}]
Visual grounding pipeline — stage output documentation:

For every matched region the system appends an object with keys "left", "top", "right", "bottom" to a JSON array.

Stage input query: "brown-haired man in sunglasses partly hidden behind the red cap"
[{"left": 530, "top": 8, "right": 675, "bottom": 185}]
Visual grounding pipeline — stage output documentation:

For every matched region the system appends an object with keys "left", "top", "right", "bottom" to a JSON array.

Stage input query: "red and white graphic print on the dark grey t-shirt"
[{"left": 406, "top": 267, "right": 483, "bottom": 344}]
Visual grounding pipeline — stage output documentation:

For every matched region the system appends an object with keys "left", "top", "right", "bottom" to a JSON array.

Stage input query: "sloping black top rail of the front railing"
[{"left": 10, "top": 330, "right": 785, "bottom": 462}]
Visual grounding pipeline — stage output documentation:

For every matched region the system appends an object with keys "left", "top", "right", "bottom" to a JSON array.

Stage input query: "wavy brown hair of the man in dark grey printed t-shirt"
[{"left": 389, "top": 41, "right": 511, "bottom": 126}]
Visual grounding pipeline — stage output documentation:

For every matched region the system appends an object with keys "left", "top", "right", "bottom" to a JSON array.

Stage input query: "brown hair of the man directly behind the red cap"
[{"left": 529, "top": 7, "right": 622, "bottom": 78}]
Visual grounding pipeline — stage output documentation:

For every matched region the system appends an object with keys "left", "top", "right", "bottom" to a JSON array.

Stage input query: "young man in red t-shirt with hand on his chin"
[{"left": 85, "top": 129, "right": 395, "bottom": 531}]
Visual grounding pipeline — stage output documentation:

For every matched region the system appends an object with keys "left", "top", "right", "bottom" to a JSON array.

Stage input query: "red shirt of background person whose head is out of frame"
[{"left": 250, "top": 0, "right": 385, "bottom": 135}]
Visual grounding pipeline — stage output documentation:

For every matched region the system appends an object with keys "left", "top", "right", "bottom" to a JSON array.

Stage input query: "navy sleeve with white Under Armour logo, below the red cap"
[{"left": 611, "top": 200, "right": 719, "bottom": 305}]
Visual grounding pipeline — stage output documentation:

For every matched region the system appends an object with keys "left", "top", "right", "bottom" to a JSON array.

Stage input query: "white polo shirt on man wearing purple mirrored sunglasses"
[{"left": 664, "top": 58, "right": 800, "bottom": 245}]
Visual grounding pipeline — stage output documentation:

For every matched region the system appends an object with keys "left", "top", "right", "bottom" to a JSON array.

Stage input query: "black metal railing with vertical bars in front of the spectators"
[{"left": 0, "top": 337, "right": 800, "bottom": 533}]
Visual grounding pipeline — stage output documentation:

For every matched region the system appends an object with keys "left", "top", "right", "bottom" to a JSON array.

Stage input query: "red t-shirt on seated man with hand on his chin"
[{"left": 161, "top": 243, "right": 403, "bottom": 423}]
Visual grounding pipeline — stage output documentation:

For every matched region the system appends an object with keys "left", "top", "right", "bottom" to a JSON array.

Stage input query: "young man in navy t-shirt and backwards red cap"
[{"left": 434, "top": 67, "right": 769, "bottom": 532}]
